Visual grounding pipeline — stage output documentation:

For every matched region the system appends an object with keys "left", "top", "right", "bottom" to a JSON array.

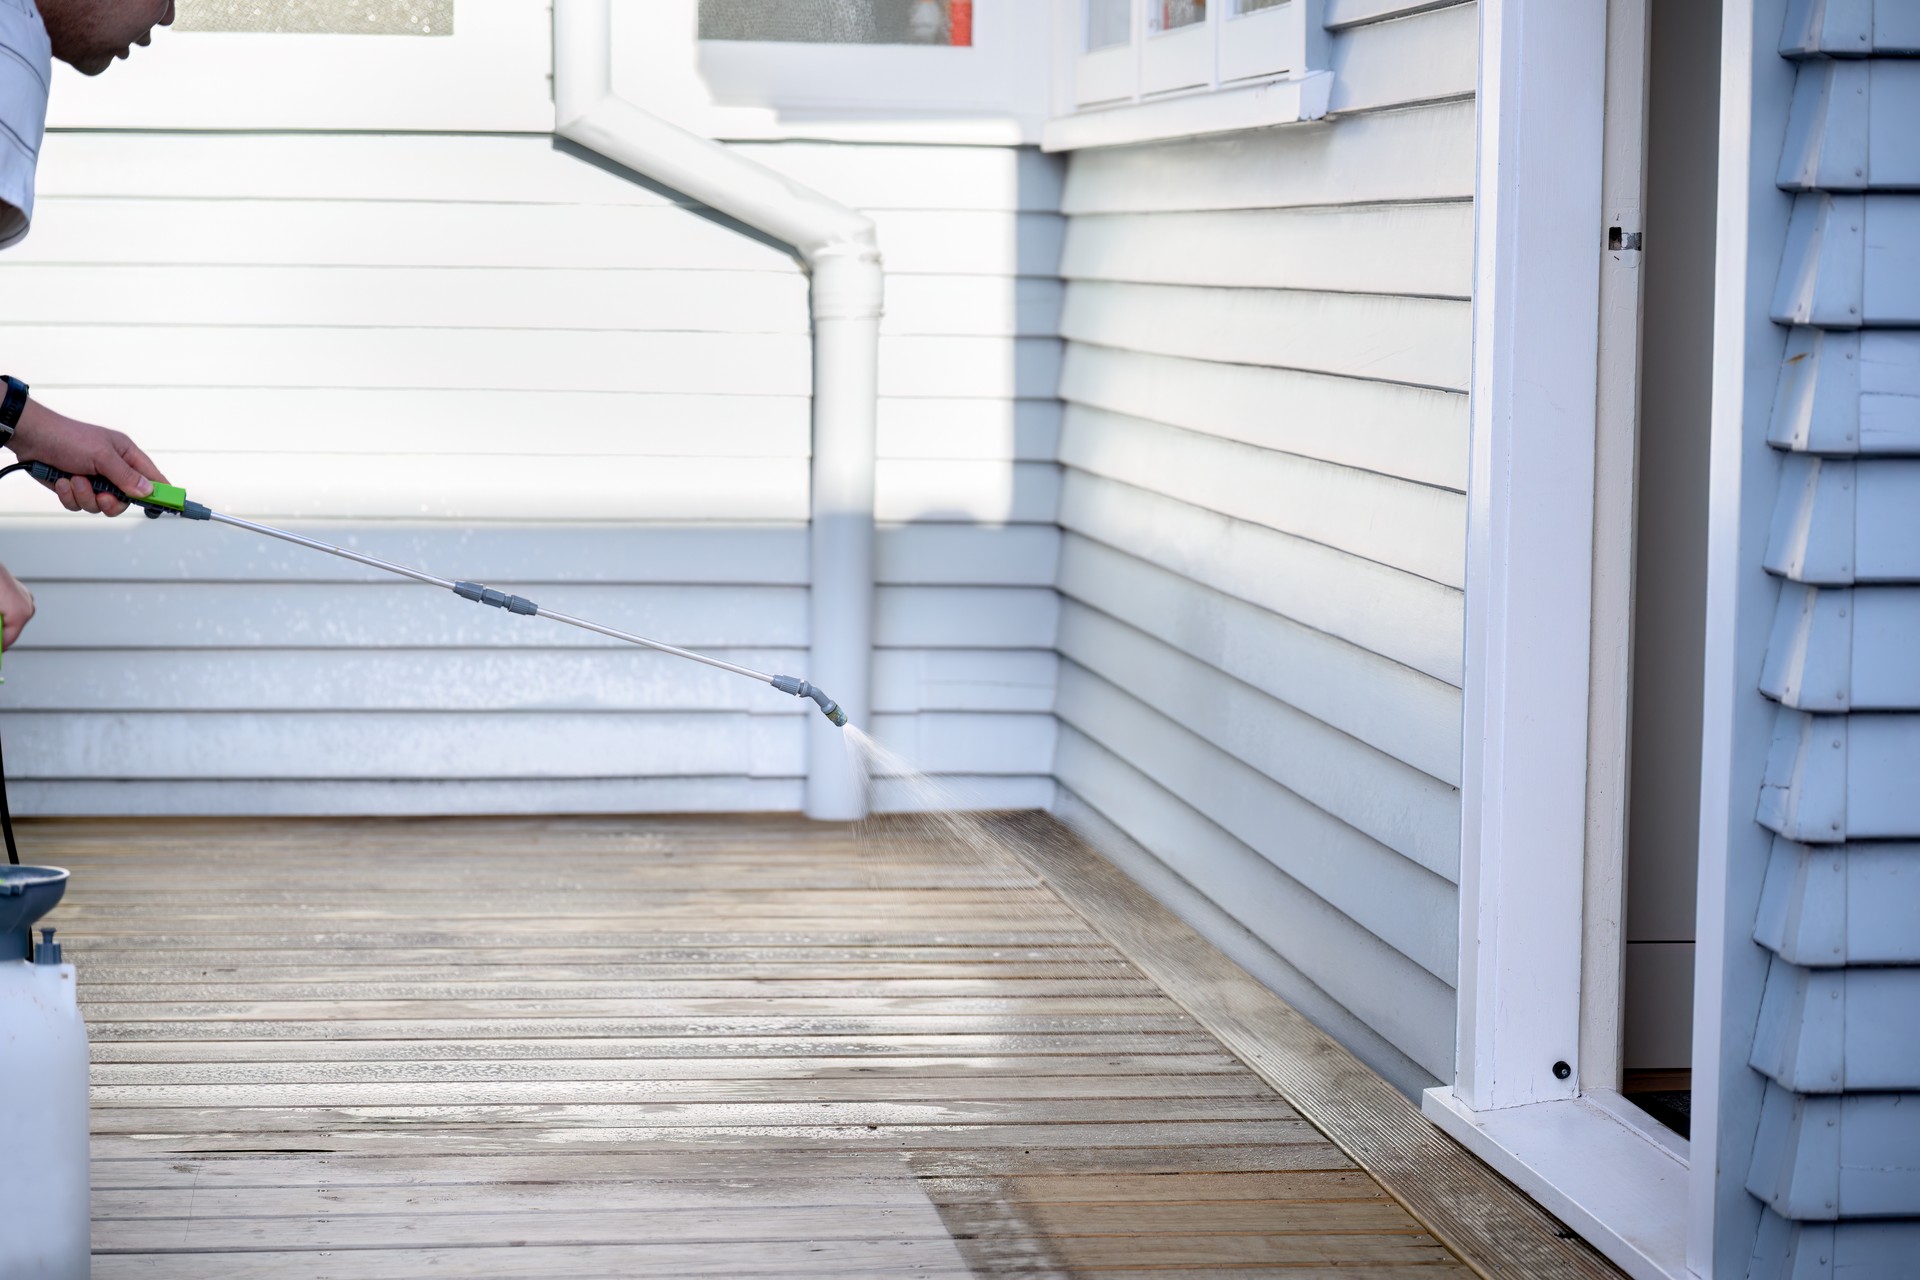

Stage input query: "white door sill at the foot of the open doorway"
[{"left": 1421, "top": 1086, "right": 1688, "bottom": 1280}]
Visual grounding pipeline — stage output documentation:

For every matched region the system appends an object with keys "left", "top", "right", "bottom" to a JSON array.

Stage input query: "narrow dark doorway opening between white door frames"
[{"left": 1620, "top": 0, "right": 1720, "bottom": 1136}]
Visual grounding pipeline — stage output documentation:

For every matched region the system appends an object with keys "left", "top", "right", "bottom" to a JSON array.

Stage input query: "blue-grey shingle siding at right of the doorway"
[{"left": 1745, "top": 0, "right": 1920, "bottom": 1280}]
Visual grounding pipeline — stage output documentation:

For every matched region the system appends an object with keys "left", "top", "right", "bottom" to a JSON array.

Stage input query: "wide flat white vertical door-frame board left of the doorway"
[{"left": 1453, "top": 0, "right": 1607, "bottom": 1111}]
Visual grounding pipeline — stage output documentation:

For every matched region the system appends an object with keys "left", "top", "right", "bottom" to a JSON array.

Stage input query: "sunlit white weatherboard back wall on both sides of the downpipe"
[{"left": 0, "top": 132, "right": 1064, "bottom": 814}]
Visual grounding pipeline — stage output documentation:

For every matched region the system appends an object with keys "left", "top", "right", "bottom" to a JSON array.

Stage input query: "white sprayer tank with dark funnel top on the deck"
[{"left": 0, "top": 865, "right": 92, "bottom": 1280}]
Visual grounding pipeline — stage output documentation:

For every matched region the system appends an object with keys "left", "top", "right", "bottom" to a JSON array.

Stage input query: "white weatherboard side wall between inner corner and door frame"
[{"left": 1056, "top": 2, "right": 1476, "bottom": 1090}]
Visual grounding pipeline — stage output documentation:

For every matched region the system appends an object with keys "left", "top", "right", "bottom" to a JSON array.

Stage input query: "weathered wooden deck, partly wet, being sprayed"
[{"left": 21, "top": 818, "right": 1611, "bottom": 1280}]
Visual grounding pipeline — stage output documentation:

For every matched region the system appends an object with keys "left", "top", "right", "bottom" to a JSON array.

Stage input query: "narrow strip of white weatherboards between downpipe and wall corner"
[{"left": 867, "top": 148, "right": 1066, "bottom": 810}]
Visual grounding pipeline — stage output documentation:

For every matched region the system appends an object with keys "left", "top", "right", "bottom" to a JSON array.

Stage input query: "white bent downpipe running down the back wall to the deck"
[{"left": 553, "top": 0, "right": 881, "bottom": 821}]
